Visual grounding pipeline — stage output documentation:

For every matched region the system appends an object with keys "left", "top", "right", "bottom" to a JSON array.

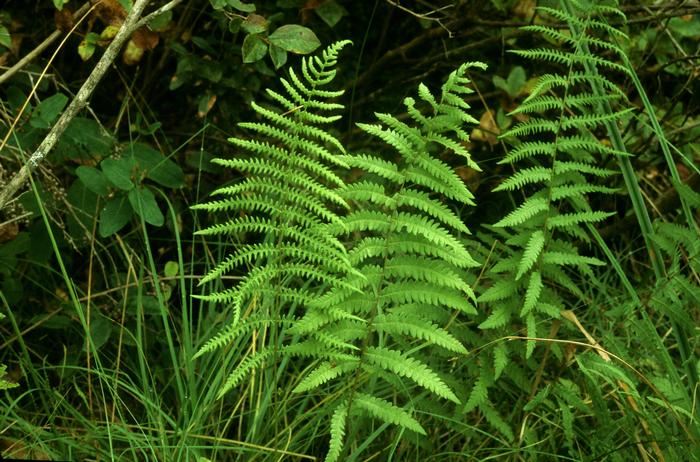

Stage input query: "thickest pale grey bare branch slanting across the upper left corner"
[{"left": 0, "top": 0, "right": 182, "bottom": 210}]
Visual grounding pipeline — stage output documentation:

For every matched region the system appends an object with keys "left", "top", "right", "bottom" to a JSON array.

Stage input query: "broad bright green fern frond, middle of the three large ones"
[{"left": 293, "top": 63, "right": 483, "bottom": 461}]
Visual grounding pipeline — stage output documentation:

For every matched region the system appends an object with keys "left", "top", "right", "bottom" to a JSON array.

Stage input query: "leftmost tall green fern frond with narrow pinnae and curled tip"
[{"left": 195, "top": 41, "right": 350, "bottom": 396}]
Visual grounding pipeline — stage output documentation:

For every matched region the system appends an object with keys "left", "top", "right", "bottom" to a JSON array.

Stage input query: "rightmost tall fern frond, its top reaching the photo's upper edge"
[{"left": 466, "top": 0, "right": 631, "bottom": 448}]
